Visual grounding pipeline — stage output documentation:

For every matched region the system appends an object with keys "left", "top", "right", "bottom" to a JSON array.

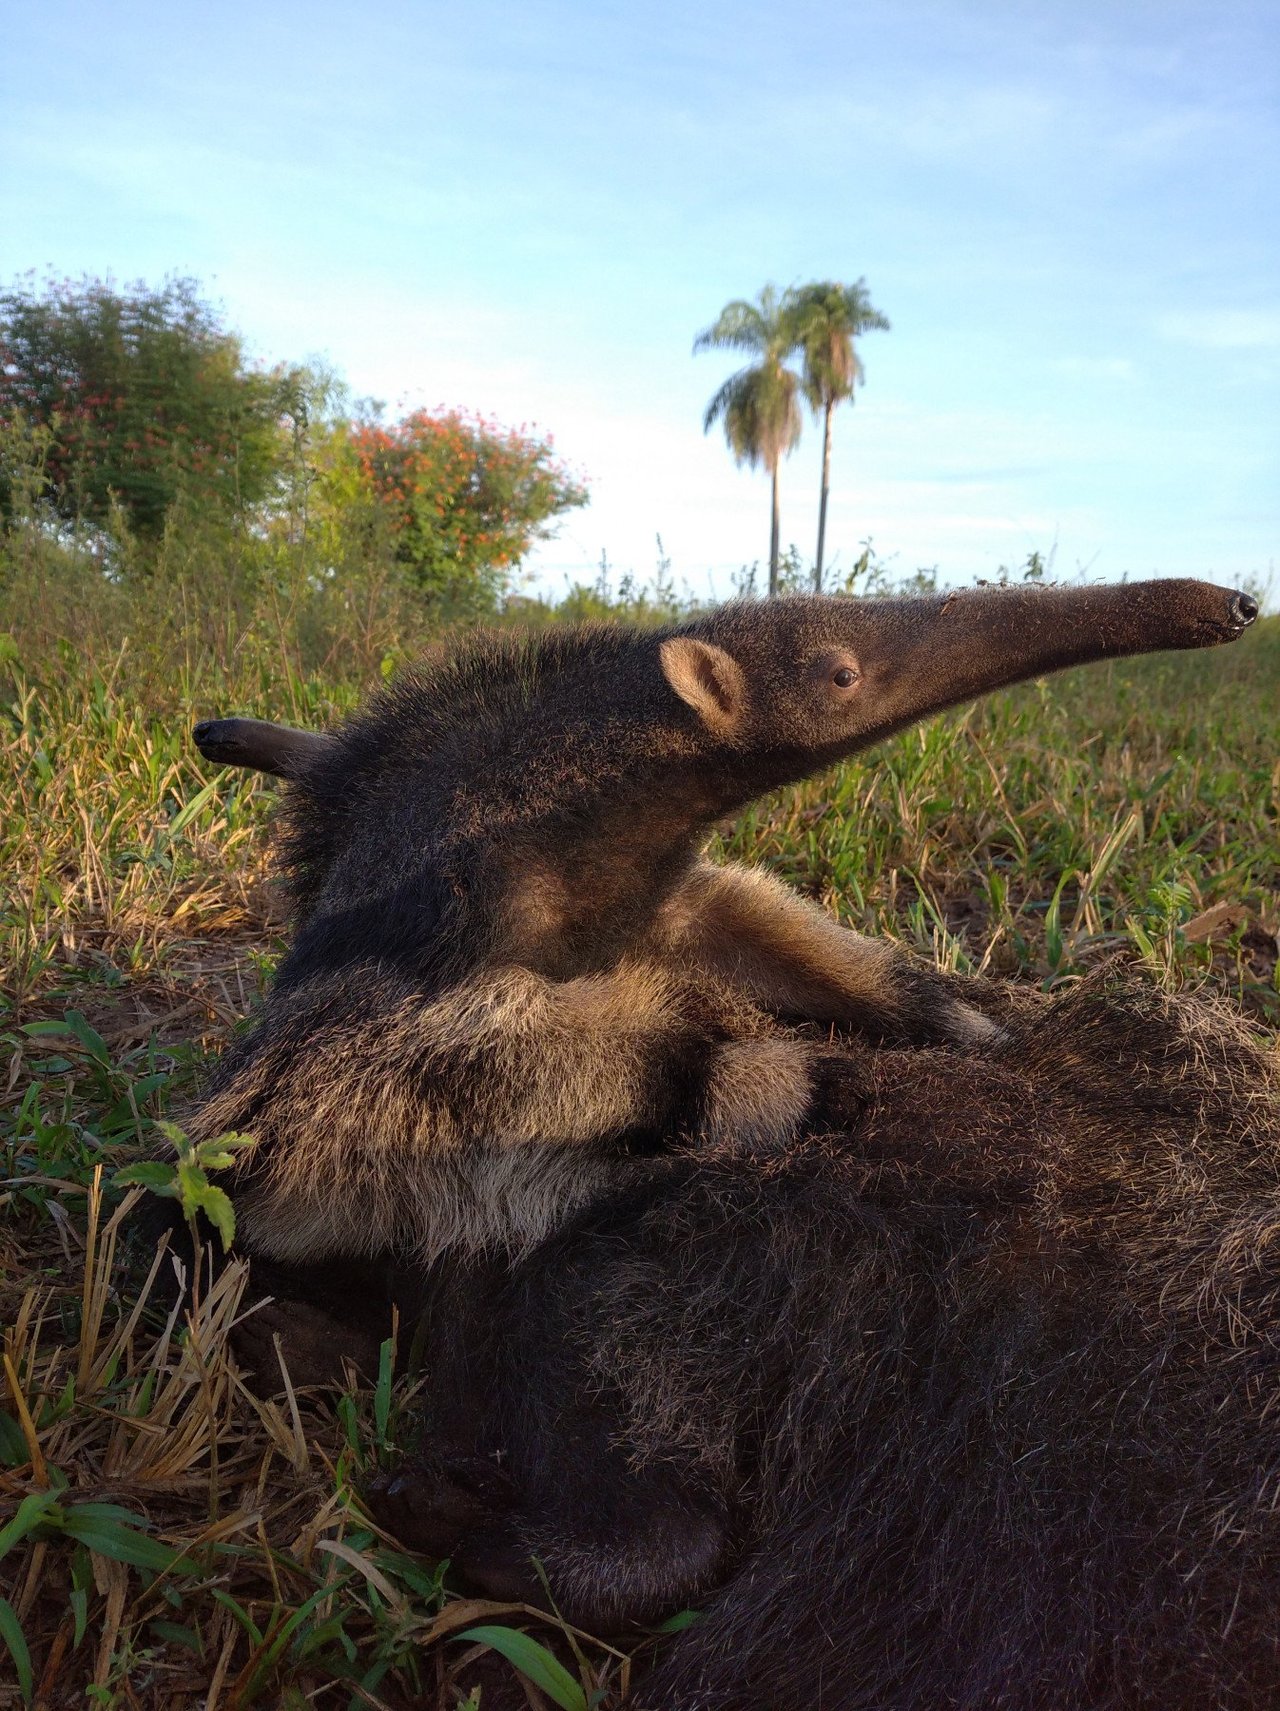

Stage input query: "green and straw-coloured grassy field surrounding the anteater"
[{"left": 0, "top": 619, "right": 1280, "bottom": 1708}]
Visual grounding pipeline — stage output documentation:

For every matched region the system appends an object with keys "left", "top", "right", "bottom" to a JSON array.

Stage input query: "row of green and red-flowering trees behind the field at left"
[{"left": 0, "top": 279, "right": 587, "bottom": 653}]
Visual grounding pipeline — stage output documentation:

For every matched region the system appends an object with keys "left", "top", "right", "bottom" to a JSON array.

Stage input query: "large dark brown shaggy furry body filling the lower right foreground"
[{"left": 373, "top": 980, "right": 1280, "bottom": 1711}]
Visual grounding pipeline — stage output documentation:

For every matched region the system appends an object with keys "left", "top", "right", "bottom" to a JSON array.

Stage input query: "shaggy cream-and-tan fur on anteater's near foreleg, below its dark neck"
[{"left": 192, "top": 963, "right": 763, "bottom": 1259}]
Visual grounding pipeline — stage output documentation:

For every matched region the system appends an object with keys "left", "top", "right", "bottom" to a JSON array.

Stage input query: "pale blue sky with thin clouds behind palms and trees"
[{"left": 0, "top": 0, "right": 1280, "bottom": 594}]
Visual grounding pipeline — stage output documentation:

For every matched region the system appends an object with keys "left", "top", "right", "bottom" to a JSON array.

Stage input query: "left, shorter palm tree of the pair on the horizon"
[{"left": 693, "top": 286, "right": 801, "bottom": 595}]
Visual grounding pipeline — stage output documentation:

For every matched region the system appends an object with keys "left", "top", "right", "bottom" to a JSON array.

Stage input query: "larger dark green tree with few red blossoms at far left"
[{"left": 0, "top": 279, "right": 296, "bottom": 539}]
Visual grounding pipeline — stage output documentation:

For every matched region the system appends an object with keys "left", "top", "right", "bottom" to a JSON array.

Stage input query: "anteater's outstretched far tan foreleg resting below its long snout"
[{"left": 657, "top": 861, "right": 999, "bottom": 1045}]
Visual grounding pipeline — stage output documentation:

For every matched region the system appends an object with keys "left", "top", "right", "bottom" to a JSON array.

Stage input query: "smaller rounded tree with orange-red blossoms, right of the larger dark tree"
[{"left": 349, "top": 411, "right": 587, "bottom": 609}]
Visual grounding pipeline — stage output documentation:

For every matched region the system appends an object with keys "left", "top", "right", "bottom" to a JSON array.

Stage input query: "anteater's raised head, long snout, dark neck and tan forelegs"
[{"left": 190, "top": 582, "right": 1256, "bottom": 1264}]
